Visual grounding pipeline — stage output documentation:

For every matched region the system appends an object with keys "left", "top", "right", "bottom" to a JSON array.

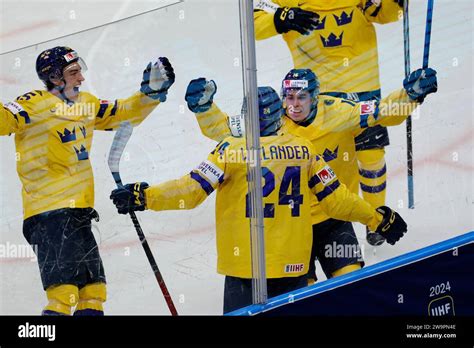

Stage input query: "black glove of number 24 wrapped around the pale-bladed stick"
[{"left": 110, "top": 182, "right": 149, "bottom": 214}]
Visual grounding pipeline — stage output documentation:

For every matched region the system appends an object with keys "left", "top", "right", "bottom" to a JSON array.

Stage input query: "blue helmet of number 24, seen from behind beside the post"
[{"left": 258, "top": 86, "right": 285, "bottom": 137}]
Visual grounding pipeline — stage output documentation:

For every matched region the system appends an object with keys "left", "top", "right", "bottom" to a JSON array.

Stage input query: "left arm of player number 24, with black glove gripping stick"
[{"left": 110, "top": 142, "right": 228, "bottom": 214}]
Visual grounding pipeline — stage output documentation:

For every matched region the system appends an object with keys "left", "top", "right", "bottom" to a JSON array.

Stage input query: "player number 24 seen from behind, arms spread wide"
[{"left": 110, "top": 87, "right": 406, "bottom": 313}]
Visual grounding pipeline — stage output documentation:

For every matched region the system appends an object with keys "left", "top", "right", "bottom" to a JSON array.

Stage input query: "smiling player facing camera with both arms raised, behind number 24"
[{"left": 186, "top": 68, "right": 437, "bottom": 279}]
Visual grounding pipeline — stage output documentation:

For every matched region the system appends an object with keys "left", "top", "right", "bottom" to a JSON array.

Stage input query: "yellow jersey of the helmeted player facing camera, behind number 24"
[{"left": 196, "top": 89, "right": 418, "bottom": 223}]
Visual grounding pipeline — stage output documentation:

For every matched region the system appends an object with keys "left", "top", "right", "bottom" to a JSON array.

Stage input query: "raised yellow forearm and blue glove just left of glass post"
[{"left": 184, "top": 77, "right": 232, "bottom": 141}]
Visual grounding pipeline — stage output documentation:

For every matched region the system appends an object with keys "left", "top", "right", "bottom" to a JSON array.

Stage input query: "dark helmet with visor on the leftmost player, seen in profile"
[{"left": 36, "top": 46, "right": 87, "bottom": 89}]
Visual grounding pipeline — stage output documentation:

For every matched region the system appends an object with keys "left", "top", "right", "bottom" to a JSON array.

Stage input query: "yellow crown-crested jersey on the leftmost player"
[{"left": 0, "top": 90, "right": 159, "bottom": 219}]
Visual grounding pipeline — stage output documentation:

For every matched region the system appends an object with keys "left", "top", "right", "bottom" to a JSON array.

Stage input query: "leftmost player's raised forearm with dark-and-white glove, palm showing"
[{"left": 95, "top": 57, "right": 175, "bottom": 130}]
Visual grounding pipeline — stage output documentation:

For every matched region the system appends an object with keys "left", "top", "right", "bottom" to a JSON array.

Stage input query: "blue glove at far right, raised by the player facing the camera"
[{"left": 403, "top": 68, "right": 438, "bottom": 103}]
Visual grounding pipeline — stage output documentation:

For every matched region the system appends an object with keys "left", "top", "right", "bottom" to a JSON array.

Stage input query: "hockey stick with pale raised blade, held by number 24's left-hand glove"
[{"left": 108, "top": 122, "right": 178, "bottom": 315}]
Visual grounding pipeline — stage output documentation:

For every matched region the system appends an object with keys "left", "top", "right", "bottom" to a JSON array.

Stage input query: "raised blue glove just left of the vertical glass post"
[{"left": 184, "top": 77, "right": 217, "bottom": 113}]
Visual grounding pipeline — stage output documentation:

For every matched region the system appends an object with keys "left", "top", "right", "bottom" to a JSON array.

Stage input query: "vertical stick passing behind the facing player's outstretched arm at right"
[{"left": 403, "top": 0, "right": 415, "bottom": 209}]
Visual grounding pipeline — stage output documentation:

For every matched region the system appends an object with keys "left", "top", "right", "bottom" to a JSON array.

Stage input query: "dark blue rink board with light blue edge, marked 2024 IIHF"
[{"left": 229, "top": 232, "right": 474, "bottom": 316}]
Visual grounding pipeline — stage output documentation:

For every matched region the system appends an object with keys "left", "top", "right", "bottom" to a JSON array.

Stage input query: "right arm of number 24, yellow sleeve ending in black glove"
[{"left": 309, "top": 156, "right": 407, "bottom": 244}]
